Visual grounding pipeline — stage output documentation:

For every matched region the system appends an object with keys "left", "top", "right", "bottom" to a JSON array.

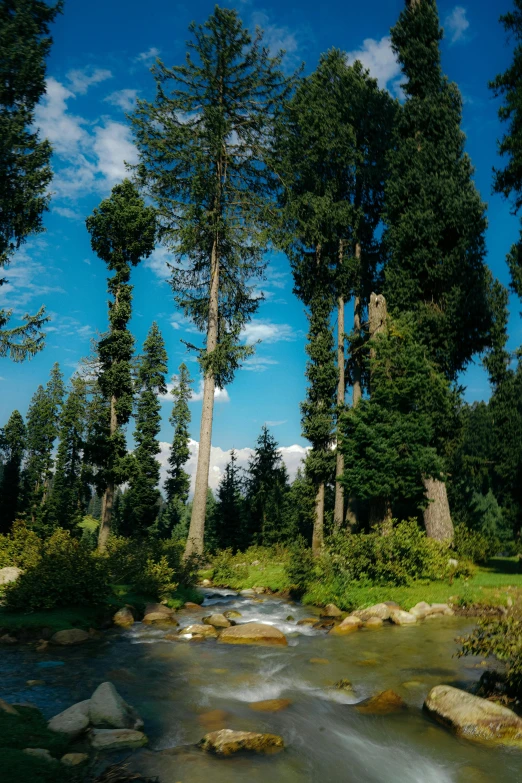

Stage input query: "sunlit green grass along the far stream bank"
[{"left": 200, "top": 558, "right": 522, "bottom": 611}]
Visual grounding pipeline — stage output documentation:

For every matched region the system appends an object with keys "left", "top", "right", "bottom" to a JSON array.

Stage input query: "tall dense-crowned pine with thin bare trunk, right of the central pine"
[{"left": 274, "top": 49, "right": 396, "bottom": 527}]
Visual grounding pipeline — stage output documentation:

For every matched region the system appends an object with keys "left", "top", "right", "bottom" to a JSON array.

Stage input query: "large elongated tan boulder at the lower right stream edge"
[{"left": 424, "top": 685, "right": 522, "bottom": 748}]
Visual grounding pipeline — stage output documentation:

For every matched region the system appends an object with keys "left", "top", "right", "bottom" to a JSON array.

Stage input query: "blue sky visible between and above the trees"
[{"left": 0, "top": 0, "right": 522, "bottom": 484}]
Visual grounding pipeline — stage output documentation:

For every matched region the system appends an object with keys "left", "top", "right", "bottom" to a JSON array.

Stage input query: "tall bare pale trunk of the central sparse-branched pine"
[{"left": 185, "top": 238, "right": 219, "bottom": 558}]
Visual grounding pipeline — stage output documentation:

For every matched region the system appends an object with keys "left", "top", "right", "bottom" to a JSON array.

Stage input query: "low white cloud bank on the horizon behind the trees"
[{"left": 158, "top": 440, "right": 308, "bottom": 494}]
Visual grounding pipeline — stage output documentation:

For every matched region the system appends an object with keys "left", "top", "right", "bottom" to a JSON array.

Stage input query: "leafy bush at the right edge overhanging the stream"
[{"left": 457, "top": 617, "right": 522, "bottom": 699}]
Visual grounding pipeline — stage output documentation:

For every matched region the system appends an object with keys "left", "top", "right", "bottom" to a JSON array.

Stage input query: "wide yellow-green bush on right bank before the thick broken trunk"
[{"left": 321, "top": 520, "right": 451, "bottom": 586}]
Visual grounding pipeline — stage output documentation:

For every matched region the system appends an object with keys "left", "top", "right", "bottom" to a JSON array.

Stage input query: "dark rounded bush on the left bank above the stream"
[{"left": 5, "top": 528, "right": 110, "bottom": 611}]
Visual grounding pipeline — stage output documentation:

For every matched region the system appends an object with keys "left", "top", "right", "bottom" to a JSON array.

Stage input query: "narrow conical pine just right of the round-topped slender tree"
[{"left": 119, "top": 323, "right": 167, "bottom": 535}]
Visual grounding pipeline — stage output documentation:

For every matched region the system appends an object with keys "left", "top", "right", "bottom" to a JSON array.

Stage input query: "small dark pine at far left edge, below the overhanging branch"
[{"left": 0, "top": 411, "right": 26, "bottom": 534}]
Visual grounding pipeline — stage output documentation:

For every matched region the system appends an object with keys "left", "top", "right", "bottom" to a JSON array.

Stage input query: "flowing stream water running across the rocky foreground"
[{"left": 0, "top": 591, "right": 522, "bottom": 783}]
